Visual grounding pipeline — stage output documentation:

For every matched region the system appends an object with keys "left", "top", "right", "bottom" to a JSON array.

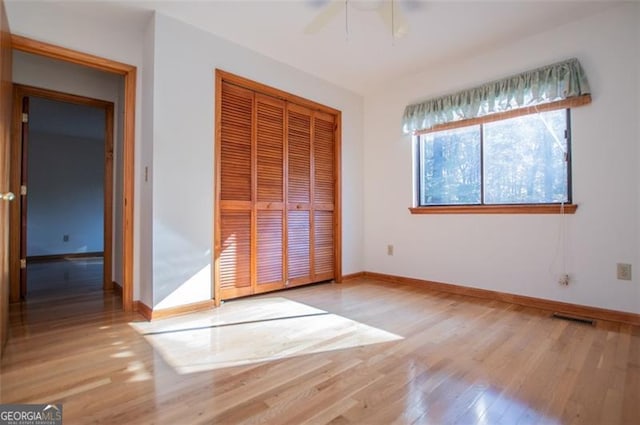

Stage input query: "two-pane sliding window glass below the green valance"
[{"left": 415, "top": 109, "right": 571, "bottom": 212}]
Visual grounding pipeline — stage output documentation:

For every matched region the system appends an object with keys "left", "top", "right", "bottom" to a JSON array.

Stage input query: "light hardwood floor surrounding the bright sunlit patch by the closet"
[{"left": 0, "top": 262, "right": 640, "bottom": 425}]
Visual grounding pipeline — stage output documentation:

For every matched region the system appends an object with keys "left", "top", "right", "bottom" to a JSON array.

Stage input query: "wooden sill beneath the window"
[{"left": 409, "top": 204, "right": 578, "bottom": 214}]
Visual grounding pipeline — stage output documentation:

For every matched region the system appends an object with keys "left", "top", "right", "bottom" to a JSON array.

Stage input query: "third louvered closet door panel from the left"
[{"left": 287, "top": 104, "right": 313, "bottom": 285}]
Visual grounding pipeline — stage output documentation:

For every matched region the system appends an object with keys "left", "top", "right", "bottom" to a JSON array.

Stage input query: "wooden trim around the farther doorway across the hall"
[{"left": 11, "top": 84, "right": 114, "bottom": 298}]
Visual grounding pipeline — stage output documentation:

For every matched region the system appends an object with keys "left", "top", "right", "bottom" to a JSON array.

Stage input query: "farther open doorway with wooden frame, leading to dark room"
[{"left": 14, "top": 85, "right": 114, "bottom": 299}]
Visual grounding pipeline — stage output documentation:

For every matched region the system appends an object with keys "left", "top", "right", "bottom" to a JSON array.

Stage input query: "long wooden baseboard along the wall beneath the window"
[{"left": 362, "top": 272, "right": 640, "bottom": 326}]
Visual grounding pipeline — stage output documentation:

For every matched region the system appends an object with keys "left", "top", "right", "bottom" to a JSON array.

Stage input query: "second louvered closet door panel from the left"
[{"left": 255, "top": 94, "right": 285, "bottom": 292}]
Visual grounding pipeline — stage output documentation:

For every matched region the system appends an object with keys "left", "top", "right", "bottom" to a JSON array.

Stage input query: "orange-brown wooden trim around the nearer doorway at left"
[{"left": 9, "top": 35, "right": 137, "bottom": 311}]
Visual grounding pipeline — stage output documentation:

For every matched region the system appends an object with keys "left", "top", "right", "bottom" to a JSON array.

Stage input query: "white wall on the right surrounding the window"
[{"left": 364, "top": 4, "right": 640, "bottom": 313}]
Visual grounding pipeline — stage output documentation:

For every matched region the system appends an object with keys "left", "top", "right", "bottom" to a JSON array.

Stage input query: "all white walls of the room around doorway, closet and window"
[{"left": 12, "top": 2, "right": 640, "bottom": 312}]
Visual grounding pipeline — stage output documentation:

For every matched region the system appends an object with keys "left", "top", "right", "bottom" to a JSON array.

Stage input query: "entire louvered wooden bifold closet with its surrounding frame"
[{"left": 213, "top": 70, "right": 342, "bottom": 305}]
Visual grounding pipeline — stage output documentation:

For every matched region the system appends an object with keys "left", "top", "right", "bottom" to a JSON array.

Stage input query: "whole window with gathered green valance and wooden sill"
[{"left": 402, "top": 58, "right": 591, "bottom": 214}]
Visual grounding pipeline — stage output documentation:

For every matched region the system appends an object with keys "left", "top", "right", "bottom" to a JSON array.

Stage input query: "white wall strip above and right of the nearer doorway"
[{"left": 5, "top": 0, "right": 152, "bottom": 300}]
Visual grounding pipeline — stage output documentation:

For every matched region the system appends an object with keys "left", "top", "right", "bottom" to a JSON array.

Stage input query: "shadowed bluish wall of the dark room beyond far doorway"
[{"left": 27, "top": 131, "right": 104, "bottom": 256}]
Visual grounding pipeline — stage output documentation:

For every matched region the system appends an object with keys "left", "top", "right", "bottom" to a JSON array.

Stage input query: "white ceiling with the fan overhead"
[{"left": 8, "top": 0, "right": 620, "bottom": 95}]
